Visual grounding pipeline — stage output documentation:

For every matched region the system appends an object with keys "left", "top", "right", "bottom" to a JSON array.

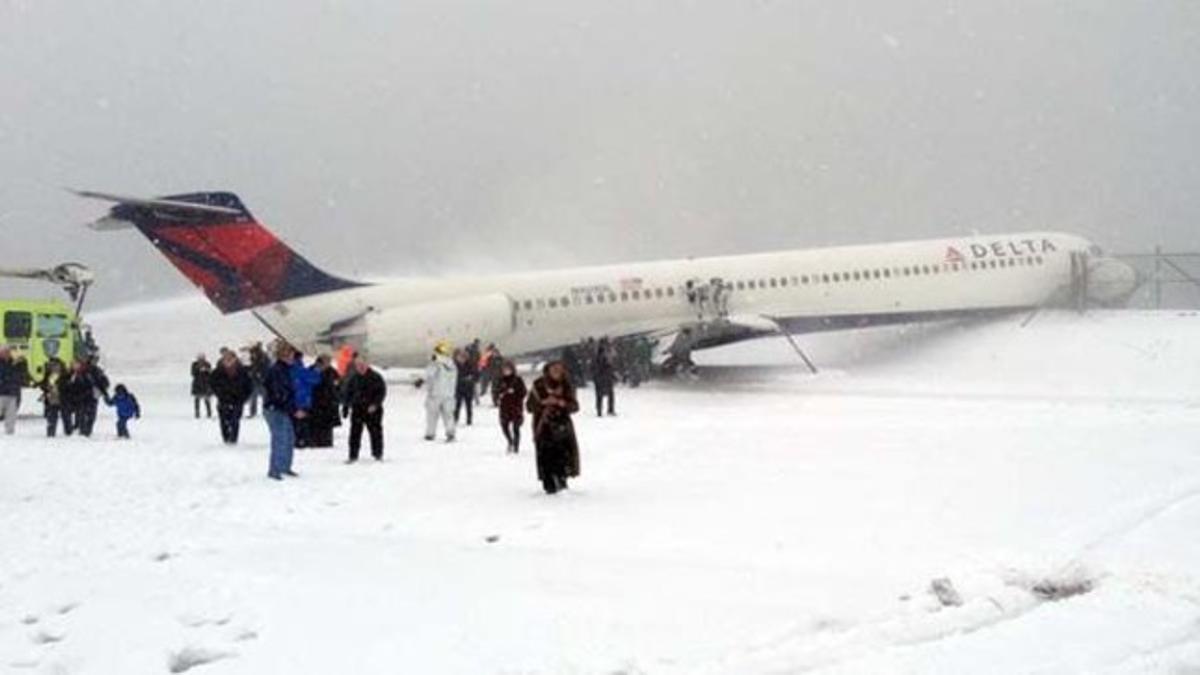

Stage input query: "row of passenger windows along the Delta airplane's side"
[{"left": 514, "top": 256, "right": 1045, "bottom": 311}]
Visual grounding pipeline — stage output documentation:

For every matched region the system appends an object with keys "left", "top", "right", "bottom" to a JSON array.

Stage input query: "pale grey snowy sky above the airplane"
[{"left": 0, "top": 0, "right": 1200, "bottom": 304}]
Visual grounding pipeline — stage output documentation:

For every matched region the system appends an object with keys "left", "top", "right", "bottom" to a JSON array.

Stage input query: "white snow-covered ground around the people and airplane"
[{"left": 0, "top": 299, "right": 1200, "bottom": 675}]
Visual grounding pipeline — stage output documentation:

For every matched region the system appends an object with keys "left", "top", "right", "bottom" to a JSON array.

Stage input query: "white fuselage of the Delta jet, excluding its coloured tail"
[{"left": 254, "top": 232, "right": 1133, "bottom": 366}]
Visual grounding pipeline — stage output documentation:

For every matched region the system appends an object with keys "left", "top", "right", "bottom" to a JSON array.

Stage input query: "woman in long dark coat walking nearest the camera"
[{"left": 526, "top": 362, "right": 580, "bottom": 495}]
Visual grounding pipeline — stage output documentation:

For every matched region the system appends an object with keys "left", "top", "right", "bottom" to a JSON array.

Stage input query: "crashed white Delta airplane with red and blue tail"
[{"left": 76, "top": 191, "right": 1140, "bottom": 368}]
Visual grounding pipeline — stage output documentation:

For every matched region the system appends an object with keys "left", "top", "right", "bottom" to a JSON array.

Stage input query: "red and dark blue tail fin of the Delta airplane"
[{"left": 78, "top": 192, "right": 361, "bottom": 313}]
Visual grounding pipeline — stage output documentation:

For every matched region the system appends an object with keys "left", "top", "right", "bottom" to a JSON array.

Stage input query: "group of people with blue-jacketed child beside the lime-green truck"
[{"left": 0, "top": 346, "right": 142, "bottom": 438}]
